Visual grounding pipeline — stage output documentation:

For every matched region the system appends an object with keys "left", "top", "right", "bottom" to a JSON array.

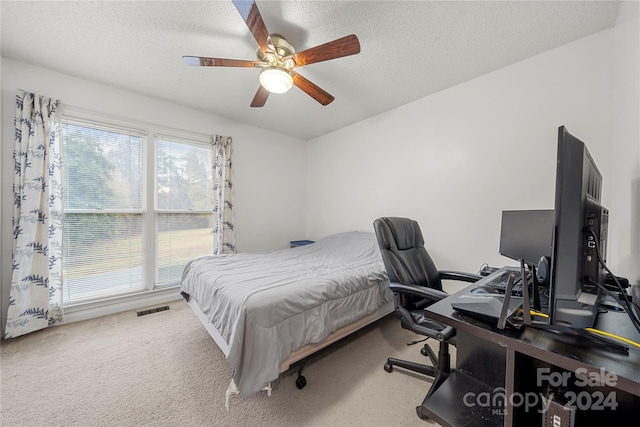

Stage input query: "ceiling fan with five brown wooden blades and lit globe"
[{"left": 182, "top": 0, "right": 360, "bottom": 107}]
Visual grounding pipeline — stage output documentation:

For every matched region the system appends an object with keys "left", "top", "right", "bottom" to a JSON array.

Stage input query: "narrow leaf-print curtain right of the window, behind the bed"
[{"left": 211, "top": 135, "right": 236, "bottom": 255}]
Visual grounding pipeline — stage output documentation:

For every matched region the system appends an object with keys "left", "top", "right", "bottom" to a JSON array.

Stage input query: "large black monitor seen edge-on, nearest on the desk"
[{"left": 549, "top": 126, "right": 609, "bottom": 328}]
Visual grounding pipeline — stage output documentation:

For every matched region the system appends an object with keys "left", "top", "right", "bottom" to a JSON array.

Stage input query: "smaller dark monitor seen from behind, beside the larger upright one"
[{"left": 500, "top": 209, "right": 555, "bottom": 267}]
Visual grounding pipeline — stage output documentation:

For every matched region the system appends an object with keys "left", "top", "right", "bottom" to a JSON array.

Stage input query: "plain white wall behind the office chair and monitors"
[{"left": 307, "top": 30, "right": 620, "bottom": 280}]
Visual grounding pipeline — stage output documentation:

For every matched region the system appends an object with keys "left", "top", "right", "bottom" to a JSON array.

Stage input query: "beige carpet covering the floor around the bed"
[{"left": 0, "top": 302, "right": 444, "bottom": 426}]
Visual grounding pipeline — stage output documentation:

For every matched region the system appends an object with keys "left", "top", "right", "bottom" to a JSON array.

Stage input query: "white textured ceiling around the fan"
[{"left": 0, "top": 0, "right": 619, "bottom": 140}]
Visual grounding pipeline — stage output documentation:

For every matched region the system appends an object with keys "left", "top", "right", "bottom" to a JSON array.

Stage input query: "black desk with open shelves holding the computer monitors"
[{"left": 422, "top": 285, "right": 640, "bottom": 427}]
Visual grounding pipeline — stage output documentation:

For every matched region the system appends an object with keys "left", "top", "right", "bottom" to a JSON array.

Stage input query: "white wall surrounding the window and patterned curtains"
[{"left": 0, "top": 58, "right": 306, "bottom": 326}]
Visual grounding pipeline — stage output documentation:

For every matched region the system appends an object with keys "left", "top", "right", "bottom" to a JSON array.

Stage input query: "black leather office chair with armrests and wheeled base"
[{"left": 373, "top": 217, "right": 481, "bottom": 419}]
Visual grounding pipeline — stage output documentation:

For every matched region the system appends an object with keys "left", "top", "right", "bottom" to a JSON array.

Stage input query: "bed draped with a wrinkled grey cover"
[{"left": 180, "top": 232, "right": 393, "bottom": 402}]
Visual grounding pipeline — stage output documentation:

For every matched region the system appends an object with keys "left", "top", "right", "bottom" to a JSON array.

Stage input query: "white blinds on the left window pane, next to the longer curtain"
[{"left": 62, "top": 120, "right": 145, "bottom": 304}]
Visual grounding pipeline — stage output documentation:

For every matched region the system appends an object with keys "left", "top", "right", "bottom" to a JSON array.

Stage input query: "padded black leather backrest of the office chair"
[{"left": 373, "top": 217, "right": 442, "bottom": 291}]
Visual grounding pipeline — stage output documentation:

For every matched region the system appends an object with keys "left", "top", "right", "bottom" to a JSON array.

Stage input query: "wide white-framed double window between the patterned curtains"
[{"left": 61, "top": 118, "right": 214, "bottom": 305}]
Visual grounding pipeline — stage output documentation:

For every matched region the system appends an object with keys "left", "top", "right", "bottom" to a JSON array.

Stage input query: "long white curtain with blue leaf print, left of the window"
[{"left": 5, "top": 90, "right": 63, "bottom": 338}]
